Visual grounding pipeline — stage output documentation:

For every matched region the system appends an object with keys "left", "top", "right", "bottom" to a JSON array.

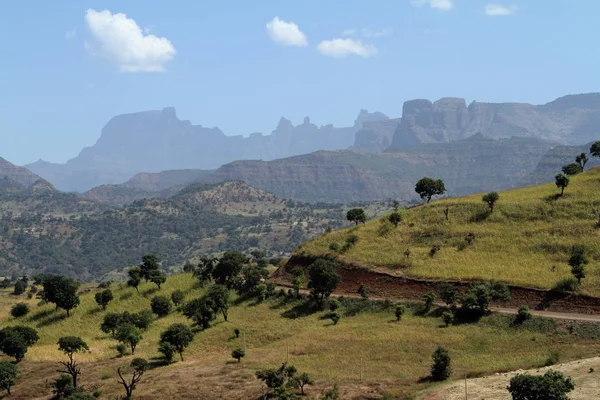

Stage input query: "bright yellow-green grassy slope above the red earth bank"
[{"left": 297, "top": 168, "right": 600, "bottom": 295}]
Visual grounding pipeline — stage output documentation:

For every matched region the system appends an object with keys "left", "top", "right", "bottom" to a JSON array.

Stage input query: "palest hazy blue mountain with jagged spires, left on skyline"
[{"left": 25, "top": 108, "right": 387, "bottom": 191}]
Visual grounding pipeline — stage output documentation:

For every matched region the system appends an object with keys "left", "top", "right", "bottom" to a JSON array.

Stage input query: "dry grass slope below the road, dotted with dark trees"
[{"left": 0, "top": 274, "right": 600, "bottom": 398}]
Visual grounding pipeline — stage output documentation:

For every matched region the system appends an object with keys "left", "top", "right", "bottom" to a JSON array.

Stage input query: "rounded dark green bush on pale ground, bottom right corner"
[{"left": 507, "top": 370, "right": 575, "bottom": 400}]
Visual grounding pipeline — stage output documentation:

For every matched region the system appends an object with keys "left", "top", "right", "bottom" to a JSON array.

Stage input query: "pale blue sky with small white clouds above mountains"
[{"left": 0, "top": 0, "right": 600, "bottom": 165}]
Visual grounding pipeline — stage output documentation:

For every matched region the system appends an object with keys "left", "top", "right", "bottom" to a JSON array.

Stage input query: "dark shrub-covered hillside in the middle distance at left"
[{"left": 0, "top": 182, "right": 382, "bottom": 280}]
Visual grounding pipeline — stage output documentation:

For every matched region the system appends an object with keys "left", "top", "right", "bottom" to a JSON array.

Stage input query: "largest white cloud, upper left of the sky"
[{"left": 85, "top": 9, "right": 176, "bottom": 72}]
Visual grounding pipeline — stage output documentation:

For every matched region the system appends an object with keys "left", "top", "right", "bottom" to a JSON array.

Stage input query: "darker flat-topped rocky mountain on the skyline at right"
[{"left": 386, "top": 93, "right": 600, "bottom": 149}]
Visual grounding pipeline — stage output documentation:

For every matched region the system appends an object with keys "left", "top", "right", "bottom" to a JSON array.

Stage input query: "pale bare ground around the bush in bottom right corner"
[{"left": 416, "top": 357, "right": 600, "bottom": 400}]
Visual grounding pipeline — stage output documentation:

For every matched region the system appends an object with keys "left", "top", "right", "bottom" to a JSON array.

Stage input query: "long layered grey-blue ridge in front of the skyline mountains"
[{"left": 84, "top": 134, "right": 555, "bottom": 204}]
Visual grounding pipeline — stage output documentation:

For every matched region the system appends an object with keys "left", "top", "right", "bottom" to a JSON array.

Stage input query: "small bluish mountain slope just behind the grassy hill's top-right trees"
[{"left": 520, "top": 141, "right": 600, "bottom": 186}]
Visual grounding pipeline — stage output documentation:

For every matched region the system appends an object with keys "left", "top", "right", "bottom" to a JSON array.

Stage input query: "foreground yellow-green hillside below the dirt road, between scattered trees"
[{"left": 0, "top": 274, "right": 600, "bottom": 400}]
